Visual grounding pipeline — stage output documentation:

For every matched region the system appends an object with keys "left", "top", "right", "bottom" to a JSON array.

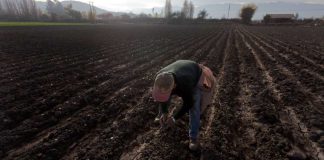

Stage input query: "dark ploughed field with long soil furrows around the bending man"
[{"left": 0, "top": 25, "right": 324, "bottom": 160}]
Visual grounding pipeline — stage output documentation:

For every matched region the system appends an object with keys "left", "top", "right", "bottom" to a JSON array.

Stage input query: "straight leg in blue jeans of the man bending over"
[{"left": 189, "top": 87, "right": 201, "bottom": 140}]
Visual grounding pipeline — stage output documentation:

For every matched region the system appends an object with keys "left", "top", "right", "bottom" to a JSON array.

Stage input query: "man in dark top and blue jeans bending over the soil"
[{"left": 152, "top": 60, "right": 215, "bottom": 151}]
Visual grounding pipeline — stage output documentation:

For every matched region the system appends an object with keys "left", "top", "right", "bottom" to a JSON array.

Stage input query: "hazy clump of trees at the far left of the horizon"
[{"left": 0, "top": 0, "right": 96, "bottom": 22}]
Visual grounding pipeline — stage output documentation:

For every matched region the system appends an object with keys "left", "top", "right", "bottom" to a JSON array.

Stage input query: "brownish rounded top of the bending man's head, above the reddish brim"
[{"left": 154, "top": 72, "right": 174, "bottom": 90}]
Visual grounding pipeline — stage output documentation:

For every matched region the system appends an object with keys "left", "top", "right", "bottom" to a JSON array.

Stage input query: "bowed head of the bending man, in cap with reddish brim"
[{"left": 153, "top": 72, "right": 175, "bottom": 102}]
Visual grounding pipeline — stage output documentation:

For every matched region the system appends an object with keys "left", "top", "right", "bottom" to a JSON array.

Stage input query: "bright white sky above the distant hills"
[{"left": 37, "top": 0, "right": 324, "bottom": 12}]
